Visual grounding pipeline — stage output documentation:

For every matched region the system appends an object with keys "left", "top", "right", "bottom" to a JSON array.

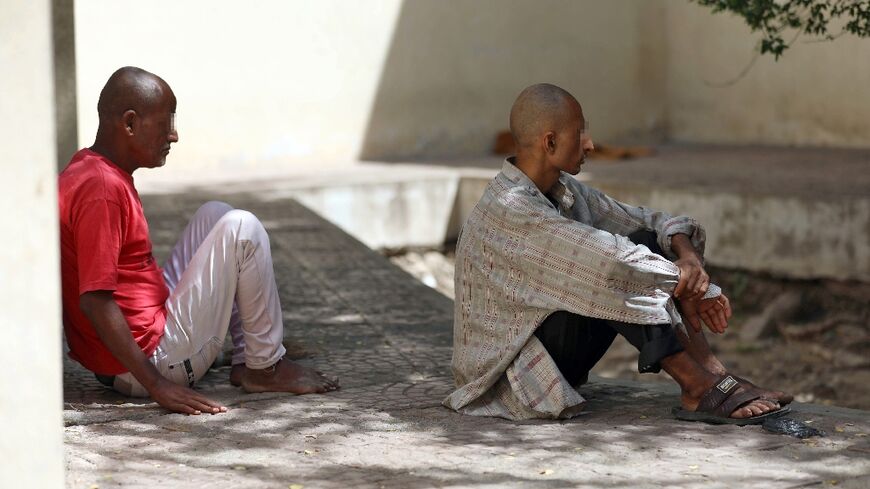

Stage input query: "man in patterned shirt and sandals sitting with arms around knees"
[{"left": 444, "top": 84, "right": 791, "bottom": 424}]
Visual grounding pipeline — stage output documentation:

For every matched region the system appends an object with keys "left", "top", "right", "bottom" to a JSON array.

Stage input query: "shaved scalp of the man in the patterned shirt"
[{"left": 510, "top": 83, "right": 580, "bottom": 147}]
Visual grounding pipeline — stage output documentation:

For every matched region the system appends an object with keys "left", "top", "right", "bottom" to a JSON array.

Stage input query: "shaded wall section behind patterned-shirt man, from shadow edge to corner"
[{"left": 362, "top": 0, "right": 665, "bottom": 159}]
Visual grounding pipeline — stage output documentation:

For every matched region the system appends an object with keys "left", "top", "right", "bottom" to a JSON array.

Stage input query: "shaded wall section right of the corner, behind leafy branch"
[{"left": 667, "top": 1, "right": 870, "bottom": 148}]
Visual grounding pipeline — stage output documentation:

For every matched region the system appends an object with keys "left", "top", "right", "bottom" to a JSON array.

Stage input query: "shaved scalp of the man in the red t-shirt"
[{"left": 97, "top": 66, "right": 171, "bottom": 124}]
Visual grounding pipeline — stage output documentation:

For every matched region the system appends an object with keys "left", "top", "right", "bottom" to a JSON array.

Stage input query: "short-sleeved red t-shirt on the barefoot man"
[{"left": 58, "top": 149, "right": 169, "bottom": 375}]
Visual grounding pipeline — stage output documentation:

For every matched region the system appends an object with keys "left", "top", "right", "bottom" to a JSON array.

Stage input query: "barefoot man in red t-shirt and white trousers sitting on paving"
[{"left": 58, "top": 67, "right": 338, "bottom": 414}]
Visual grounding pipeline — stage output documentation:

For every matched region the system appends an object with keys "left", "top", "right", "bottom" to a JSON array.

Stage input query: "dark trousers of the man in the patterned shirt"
[{"left": 535, "top": 231, "right": 683, "bottom": 385}]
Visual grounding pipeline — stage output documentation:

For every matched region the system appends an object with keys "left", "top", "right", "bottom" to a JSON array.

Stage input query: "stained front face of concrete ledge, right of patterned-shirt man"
[{"left": 590, "top": 182, "right": 870, "bottom": 282}]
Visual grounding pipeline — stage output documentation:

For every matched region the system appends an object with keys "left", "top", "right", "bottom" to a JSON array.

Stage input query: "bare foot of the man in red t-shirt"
[{"left": 240, "top": 359, "right": 339, "bottom": 394}]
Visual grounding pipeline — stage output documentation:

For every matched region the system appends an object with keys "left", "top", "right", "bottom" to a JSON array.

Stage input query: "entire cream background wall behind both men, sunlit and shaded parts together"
[{"left": 75, "top": 0, "right": 870, "bottom": 175}]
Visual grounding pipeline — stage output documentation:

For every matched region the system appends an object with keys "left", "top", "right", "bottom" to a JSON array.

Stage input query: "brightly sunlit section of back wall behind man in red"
[{"left": 75, "top": 0, "right": 401, "bottom": 177}]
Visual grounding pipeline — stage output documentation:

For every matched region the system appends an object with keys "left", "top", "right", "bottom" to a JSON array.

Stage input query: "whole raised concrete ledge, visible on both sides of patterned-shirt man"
[{"left": 137, "top": 145, "right": 870, "bottom": 282}]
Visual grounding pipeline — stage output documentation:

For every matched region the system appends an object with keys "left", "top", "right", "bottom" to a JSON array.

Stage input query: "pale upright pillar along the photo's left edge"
[{"left": 0, "top": 0, "right": 63, "bottom": 488}]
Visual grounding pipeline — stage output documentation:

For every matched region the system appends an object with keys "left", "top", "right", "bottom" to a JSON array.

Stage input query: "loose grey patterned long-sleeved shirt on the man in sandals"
[{"left": 444, "top": 158, "right": 719, "bottom": 419}]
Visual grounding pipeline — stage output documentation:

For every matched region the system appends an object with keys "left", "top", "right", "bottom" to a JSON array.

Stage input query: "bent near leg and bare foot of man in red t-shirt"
[{"left": 158, "top": 203, "right": 336, "bottom": 393}]
